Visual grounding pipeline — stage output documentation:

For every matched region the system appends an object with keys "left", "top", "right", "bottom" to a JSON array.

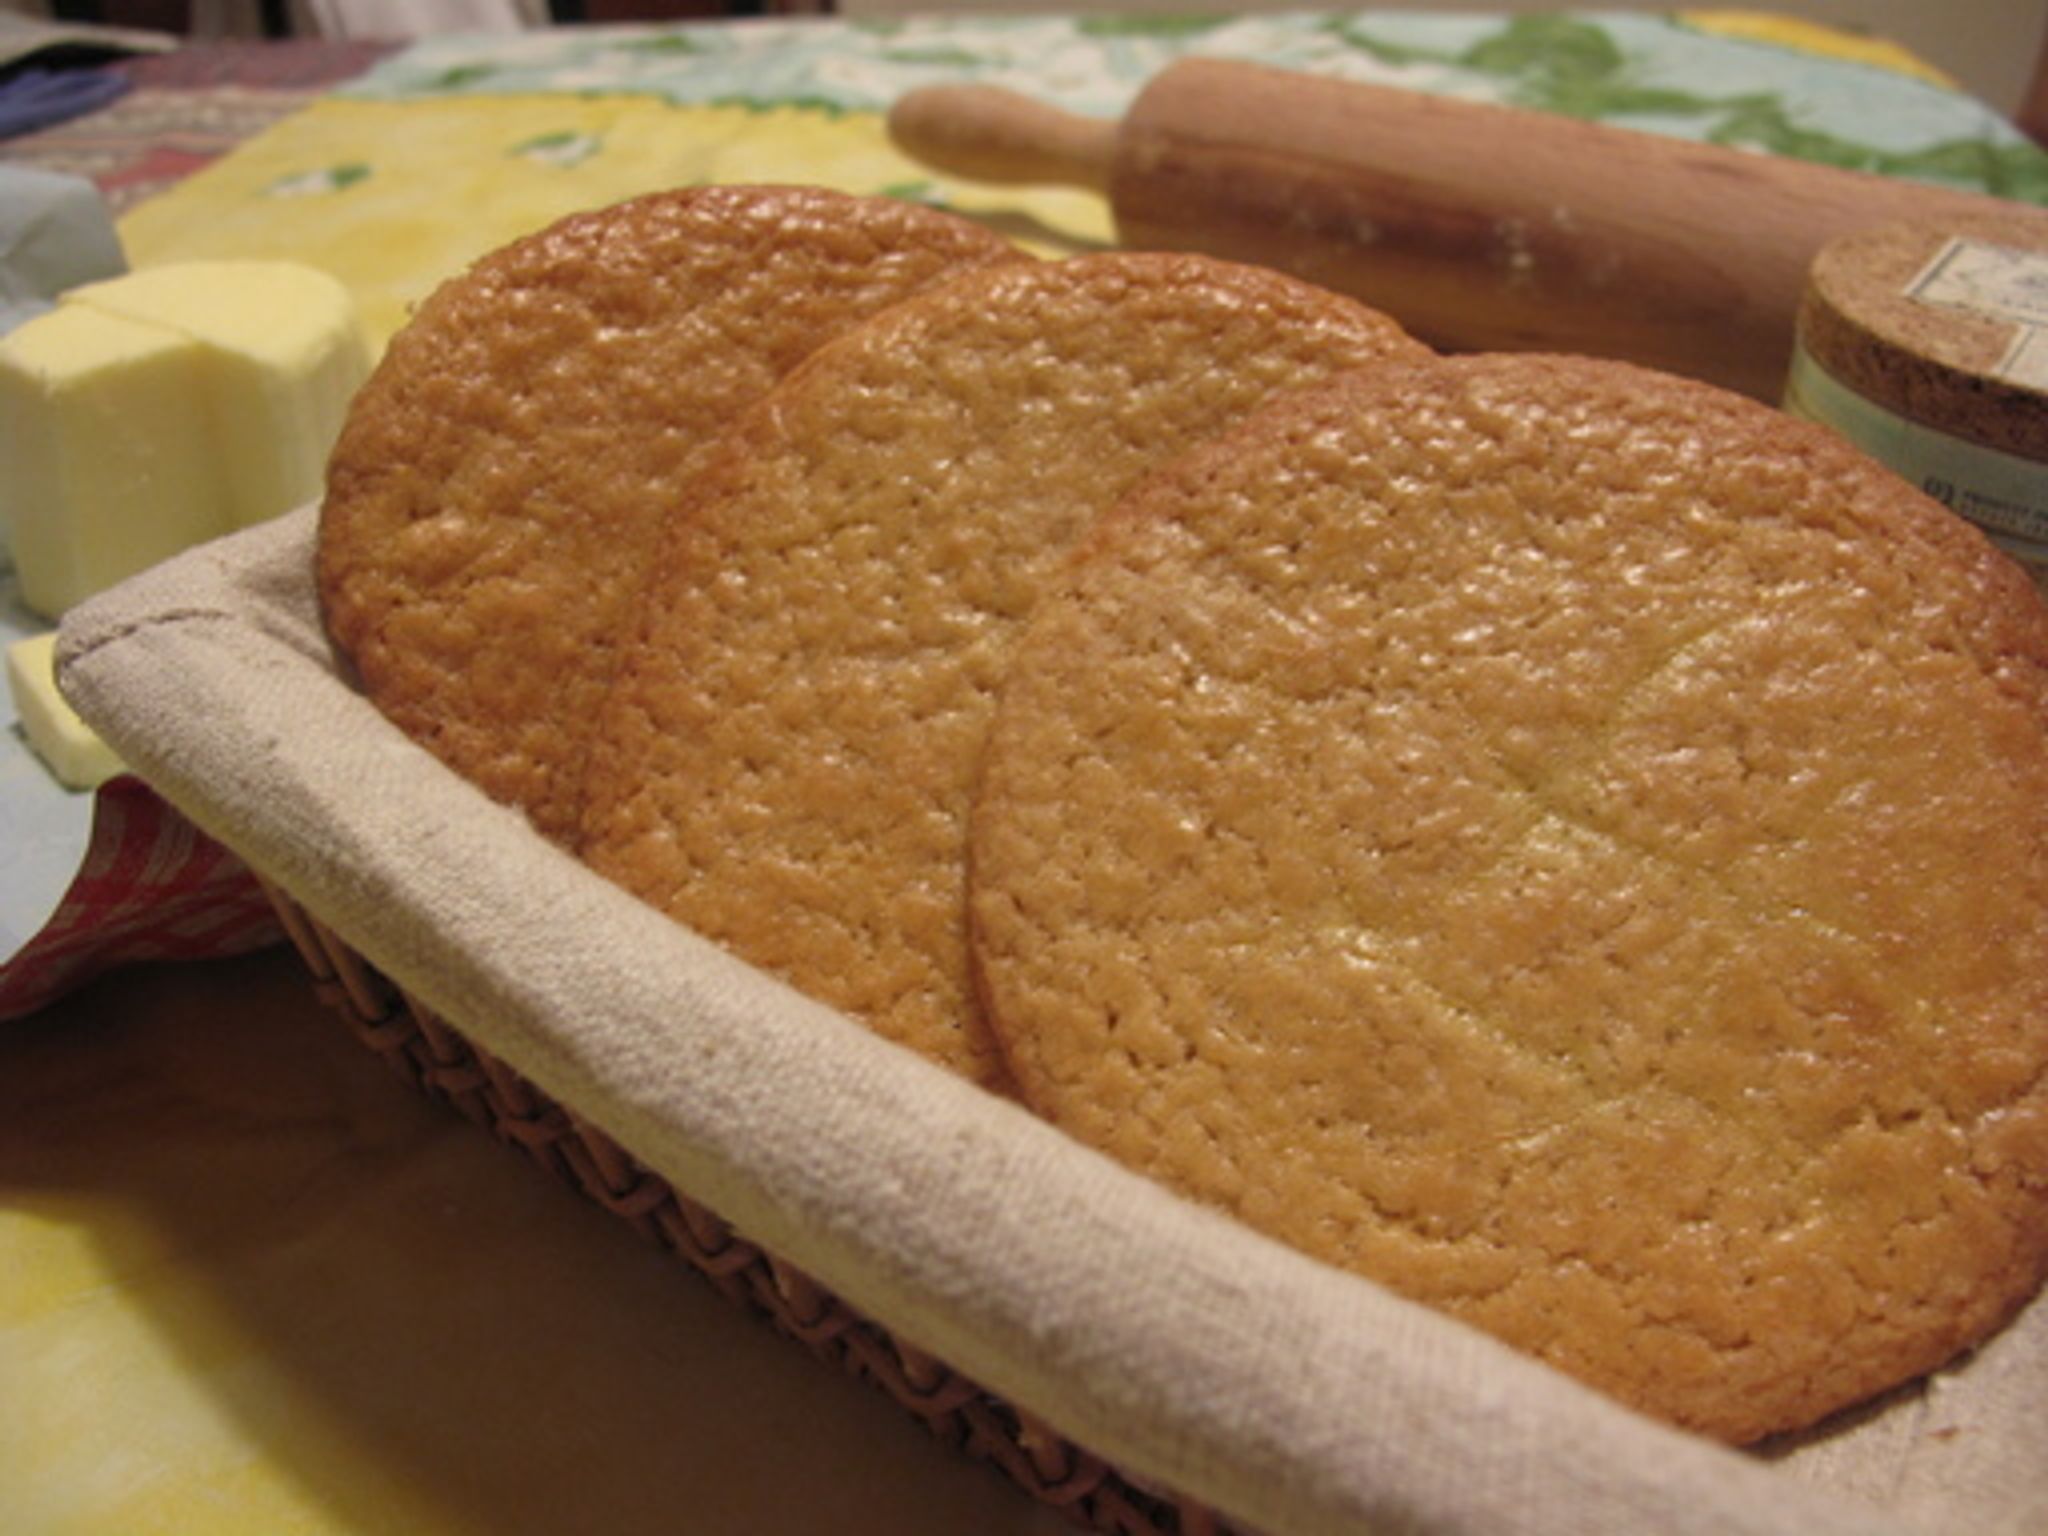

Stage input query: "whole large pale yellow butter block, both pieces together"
[{"left": 0, "top": 262, "right": 371, "bottom": 618}]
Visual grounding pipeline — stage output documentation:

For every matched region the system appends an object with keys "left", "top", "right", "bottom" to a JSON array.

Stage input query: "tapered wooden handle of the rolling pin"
[{"left": 889, "top": 86, "right": 1116, "bottom": 193}]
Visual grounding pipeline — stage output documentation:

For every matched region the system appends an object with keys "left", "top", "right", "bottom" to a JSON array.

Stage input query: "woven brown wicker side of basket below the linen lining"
[{"left": 258, "top": 877, "right": 1235, "bottom": 1536}]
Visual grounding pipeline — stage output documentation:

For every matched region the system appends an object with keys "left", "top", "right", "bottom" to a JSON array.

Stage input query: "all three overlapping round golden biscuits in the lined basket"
[{"left": 319, "top": 188, "right": 2048, "bottom": 1442}]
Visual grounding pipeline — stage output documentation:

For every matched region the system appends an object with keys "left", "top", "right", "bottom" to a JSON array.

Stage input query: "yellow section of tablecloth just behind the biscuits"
[{"left": 121, "top": 94, "right": 1110, "bottom": 348}]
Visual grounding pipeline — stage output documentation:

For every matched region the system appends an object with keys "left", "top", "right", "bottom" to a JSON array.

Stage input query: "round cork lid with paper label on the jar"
[{"left": 1798, "top": 205, "right": 2048, "bottom": 463}]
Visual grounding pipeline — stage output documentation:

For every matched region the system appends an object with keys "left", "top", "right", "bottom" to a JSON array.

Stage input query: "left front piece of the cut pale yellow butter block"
[{"left": 0, "top": 305, "right": 231, "bottom": 618}]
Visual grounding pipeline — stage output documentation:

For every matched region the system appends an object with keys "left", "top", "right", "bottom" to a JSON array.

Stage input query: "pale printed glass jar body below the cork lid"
[{"left": 1784, "top": 346, "right": 2048, "bottom": 565}]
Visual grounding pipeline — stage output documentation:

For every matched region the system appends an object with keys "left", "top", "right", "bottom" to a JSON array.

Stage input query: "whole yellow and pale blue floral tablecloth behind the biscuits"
[{"left": 108, "top": 10, "right": 2048, "bottom": 348}]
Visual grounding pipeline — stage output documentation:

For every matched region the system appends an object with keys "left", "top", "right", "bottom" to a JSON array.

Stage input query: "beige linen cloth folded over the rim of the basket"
[{"left": 61, "top": 510, "right": 2048, "bottom": 1536}]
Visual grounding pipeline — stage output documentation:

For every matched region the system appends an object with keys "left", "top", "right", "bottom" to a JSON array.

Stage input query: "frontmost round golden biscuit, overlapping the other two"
[{"left": 971, "top": 348, "right": 2048, "bottom": 1442}]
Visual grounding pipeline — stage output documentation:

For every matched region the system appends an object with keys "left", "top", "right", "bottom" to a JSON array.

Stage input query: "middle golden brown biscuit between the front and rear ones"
[{"left": 582, "top": 254, "right": 1421, "bottom": 1083}]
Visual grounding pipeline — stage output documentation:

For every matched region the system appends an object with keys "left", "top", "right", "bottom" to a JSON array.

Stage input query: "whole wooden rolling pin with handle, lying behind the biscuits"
[{"left": 889, "top": 59, "right": 2023, "bottom": 399}]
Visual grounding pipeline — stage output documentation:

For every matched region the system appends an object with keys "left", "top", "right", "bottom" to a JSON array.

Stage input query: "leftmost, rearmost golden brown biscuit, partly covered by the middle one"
[{"left": 319, "top": 186, "right": 1022, "bottom": 856}]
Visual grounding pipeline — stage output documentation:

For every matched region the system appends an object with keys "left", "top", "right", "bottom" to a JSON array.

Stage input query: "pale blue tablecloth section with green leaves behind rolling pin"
[{"left": 340, "top": 6, "right": 2048, "bottom": 201}]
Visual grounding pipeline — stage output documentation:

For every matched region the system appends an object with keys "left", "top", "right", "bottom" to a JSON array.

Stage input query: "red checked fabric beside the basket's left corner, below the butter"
[{"left": 0, "top": 776, "right": 283, "bottom": 1020}]
